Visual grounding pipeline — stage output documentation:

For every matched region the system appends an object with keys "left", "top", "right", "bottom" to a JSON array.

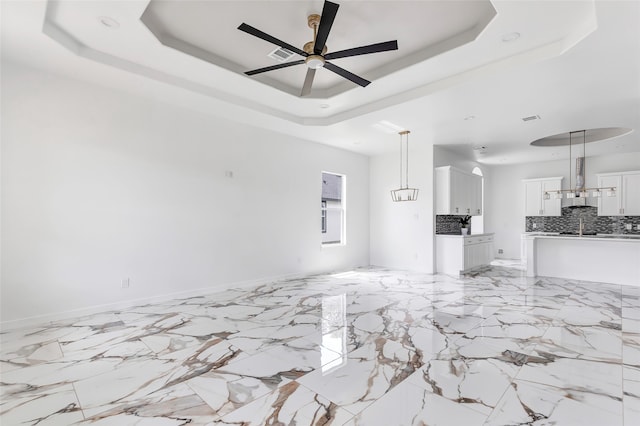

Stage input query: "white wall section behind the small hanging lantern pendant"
[{"left": 369, "top": 141, "right": 434, "bottom": 273}]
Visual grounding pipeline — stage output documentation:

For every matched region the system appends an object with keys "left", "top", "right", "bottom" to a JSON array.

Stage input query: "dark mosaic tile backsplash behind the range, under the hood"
[{"left": 528, "top": 207, "right": 640, "bottom": 234}]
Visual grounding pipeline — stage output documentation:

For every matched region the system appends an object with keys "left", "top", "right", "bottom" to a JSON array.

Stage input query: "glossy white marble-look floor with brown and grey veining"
[{"left": 0, "top": 266, "right": 640, "bottom": 426}]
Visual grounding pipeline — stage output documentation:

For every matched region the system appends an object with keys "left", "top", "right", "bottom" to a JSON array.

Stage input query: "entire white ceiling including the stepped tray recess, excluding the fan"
[{"left": 0, "top": 0, "right": 640, "bottom": 164}]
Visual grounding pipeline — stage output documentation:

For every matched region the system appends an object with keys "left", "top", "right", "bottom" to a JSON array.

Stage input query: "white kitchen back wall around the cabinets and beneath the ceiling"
[{"left": 485, "top": 152, "right": 640, "bottom": 259}]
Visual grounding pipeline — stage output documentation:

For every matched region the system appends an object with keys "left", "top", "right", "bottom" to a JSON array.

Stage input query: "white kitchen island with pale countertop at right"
[{"left": 522, "top": 233, "right": 640, "bottom": 287}]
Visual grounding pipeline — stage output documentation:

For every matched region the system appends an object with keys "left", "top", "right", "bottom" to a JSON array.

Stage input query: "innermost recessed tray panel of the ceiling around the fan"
[{"left": 141, "top": 0, "right": 496, "bottom": 98}]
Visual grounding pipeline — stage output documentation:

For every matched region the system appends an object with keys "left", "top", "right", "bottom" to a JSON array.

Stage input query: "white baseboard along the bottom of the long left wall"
[{"left": 0, "top": 272, "right": 318, "bottom": 332}]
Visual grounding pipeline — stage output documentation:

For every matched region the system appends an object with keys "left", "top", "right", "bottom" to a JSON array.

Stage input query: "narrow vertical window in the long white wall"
[{"left": 320, "top": 172, "right": 345, "bottom": 244}]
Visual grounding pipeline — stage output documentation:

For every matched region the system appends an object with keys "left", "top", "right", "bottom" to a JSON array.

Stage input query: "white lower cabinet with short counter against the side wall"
[{"left": 436, "top": 234, "right": 494, "bottom": 275}]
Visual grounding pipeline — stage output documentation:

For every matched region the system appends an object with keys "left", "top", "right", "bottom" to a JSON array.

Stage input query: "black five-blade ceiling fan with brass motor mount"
[{"left": 238, "top": 1, "right": 398, "bottom": 96}]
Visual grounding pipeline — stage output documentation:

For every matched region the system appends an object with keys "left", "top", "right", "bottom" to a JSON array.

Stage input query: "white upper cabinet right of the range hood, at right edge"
[{"left": 597, "top": 171, "right": 640, "bottom": 216}]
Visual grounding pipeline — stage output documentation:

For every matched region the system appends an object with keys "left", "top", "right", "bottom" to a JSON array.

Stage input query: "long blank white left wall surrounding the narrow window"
[{"left": 0, "top": 62, "right": 369, "bottom": 323}]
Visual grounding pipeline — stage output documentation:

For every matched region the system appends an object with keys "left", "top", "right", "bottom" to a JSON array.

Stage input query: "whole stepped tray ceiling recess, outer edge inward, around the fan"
[{"left": 43, "top": 0, "right": 597, "bottom": 126}]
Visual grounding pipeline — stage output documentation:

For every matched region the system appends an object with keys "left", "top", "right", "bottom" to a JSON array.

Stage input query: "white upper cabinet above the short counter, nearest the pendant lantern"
[{"left": 436, "top": 166, "right": 482, "bottom": 216}]
